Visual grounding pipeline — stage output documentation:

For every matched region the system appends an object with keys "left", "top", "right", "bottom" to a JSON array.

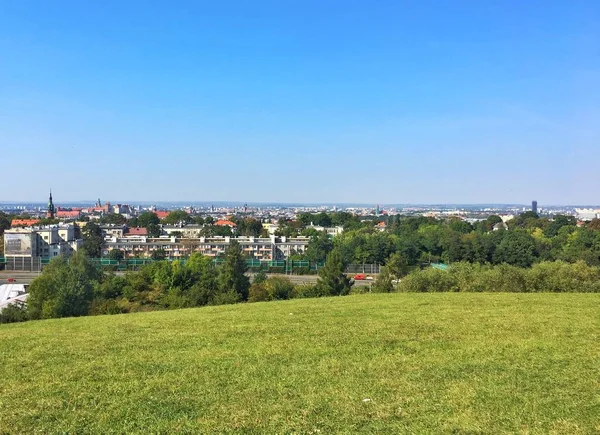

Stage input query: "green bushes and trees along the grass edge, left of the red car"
[{"left": 0, "top": 242, "right": 352, "bottom": 323}]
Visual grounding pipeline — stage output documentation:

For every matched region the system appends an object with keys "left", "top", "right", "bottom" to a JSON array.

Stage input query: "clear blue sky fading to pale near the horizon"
[{"left": 0, "top": 0, "right": 600, "bottom": 205}]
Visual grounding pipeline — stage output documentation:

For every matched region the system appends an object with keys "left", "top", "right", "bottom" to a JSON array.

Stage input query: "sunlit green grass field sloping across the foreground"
[{"left": 0, "top": 293, "right": 600, "bottom": 434}]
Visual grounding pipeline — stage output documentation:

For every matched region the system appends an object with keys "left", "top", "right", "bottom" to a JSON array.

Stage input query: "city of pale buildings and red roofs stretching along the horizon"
[{"left": 0, "top": 192, "right": 600, "bottom": 271}]
